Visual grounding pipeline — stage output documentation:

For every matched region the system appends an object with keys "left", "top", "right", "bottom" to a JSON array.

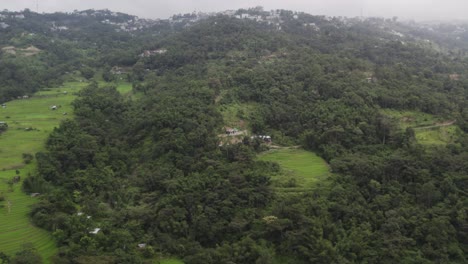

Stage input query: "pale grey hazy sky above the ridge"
[{"left": 0, "top": 0, "right": 468, "bottom": 20}]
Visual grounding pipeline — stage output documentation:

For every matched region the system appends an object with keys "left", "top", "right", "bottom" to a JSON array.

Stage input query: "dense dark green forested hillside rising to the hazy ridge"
[{"left": 2, "top": 8, "right": 468, "bottom": 263}]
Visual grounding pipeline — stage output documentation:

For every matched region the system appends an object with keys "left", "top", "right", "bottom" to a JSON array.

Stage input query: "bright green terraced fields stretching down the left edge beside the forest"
[{"left": 0, "top": 82, "right": 131, "bottom": 263}]
